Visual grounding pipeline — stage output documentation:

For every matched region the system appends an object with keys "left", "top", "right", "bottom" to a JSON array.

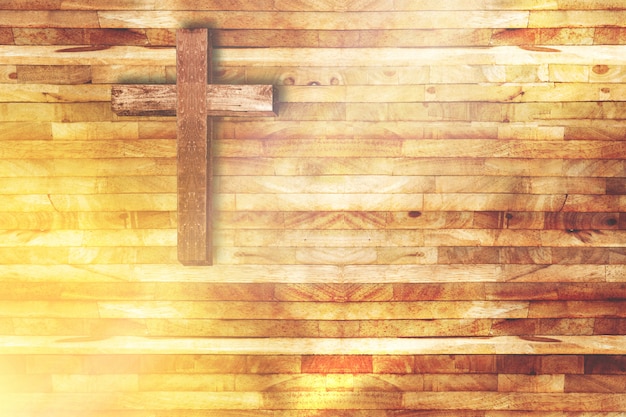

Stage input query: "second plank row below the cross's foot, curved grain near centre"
[{"left": 0, "top": 281, "right": 626, "bottom": 302}]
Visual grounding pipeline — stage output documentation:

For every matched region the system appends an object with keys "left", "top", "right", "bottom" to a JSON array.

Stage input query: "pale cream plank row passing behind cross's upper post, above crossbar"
[{"left": 6, "top": 45, "right": 626, "bottom": 66}]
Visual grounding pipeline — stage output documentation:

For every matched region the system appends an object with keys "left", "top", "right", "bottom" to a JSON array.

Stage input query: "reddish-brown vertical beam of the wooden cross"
[{"left": 176, "top": 30, "right": 213, "bottom": 265}]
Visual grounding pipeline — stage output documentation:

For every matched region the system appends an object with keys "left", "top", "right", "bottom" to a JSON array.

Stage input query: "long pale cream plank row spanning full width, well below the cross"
[{"left": 0, "top": 336, "right": 624, "bottom": 354}]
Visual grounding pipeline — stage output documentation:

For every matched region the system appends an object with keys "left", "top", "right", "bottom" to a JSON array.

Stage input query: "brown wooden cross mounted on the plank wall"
[{"left": 111, "top": 29, "right": 278, "bottom": 265}]
